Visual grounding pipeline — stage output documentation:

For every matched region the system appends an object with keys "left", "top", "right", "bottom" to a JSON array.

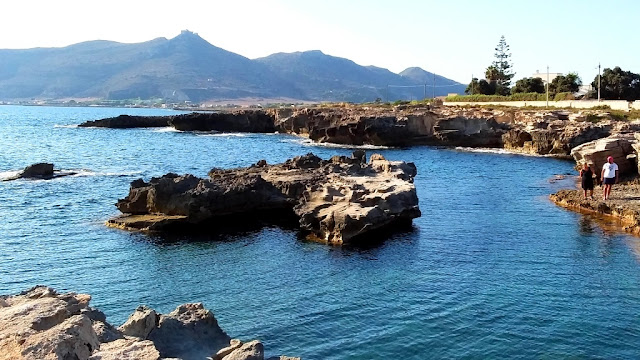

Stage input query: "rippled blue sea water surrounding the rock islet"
[{"left": 0, "top": 106, "right": 640, "bottom": 360}]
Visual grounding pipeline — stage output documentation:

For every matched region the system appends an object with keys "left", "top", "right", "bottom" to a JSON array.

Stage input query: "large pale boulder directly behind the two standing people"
[{"left": 571, "top": 134, "right": 638, "bottom": 177}]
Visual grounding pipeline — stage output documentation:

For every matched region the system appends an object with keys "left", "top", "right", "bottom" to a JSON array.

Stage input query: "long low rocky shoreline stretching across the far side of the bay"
[{"left": 79, "top": 105, "right": 640, "bottom": 157}]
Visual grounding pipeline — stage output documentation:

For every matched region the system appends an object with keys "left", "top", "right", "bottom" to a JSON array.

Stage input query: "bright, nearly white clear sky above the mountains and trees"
[{"left": 0, "top": 0, "right": 640, "bottom": 83}]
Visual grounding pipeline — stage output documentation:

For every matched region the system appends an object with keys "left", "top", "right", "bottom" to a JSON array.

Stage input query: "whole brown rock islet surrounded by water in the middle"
[{"left": 107, "top": 151, "right": 420, "bottom": 244}]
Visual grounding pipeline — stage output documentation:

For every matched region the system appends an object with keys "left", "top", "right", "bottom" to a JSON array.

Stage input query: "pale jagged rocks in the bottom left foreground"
[{"left": 0, "top": 286, "right": 299, "bottom": 360}]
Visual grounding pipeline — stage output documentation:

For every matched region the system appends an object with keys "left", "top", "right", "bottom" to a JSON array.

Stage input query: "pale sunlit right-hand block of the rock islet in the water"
[{"left": 294, "top": 154, "right": 420, "bottom": 244}]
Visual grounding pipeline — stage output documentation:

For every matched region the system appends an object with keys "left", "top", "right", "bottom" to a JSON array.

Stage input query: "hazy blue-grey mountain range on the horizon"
[{"left": 0, "top": 31, "right": 466, "bottom": 102}]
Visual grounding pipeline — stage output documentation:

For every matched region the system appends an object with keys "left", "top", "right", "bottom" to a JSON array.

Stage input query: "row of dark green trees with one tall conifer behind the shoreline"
[{"left": 465, "top": 35, "right": 640, "bottom": 101}]
